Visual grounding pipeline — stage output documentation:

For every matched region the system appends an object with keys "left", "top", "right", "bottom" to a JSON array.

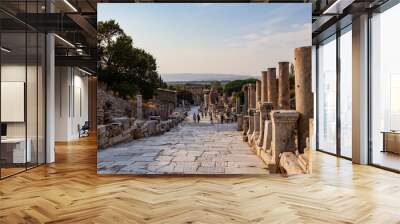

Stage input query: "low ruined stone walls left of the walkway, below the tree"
[{"left": 97, "top": 86, "right": 185, "bottom": 149}]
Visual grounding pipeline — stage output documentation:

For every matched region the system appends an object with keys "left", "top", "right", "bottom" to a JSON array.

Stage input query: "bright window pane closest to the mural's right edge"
[{"left": 317, "top": 36, "right": 337, "bottom": 154}]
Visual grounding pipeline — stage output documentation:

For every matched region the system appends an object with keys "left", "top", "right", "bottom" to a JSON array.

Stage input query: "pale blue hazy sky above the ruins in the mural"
[{"left": 98, "top": 3, "right": 311, "bottom": 75}]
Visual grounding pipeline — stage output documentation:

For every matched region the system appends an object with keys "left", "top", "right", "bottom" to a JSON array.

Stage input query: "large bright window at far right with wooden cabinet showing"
[{"left": 371, "top": 5, "right": 400, "bottom": 170}]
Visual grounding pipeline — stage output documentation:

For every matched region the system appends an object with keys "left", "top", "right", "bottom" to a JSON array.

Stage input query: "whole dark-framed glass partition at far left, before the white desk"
[{"left": 0, "top": 1, "right": 46, "bottom": 179}]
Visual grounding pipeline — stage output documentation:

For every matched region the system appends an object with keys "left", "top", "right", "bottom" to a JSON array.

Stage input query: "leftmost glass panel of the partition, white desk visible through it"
[{"left": 1, "top": 32, "right": 27, "bottom": 177}]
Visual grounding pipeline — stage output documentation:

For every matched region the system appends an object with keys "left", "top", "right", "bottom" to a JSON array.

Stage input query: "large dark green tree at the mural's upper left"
[{"left": 97, "top": 20, "right": 167, "bottom": 99}]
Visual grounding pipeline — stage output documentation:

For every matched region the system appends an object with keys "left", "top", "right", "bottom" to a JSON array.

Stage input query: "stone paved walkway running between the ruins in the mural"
[{"left": 97, "top": 107, "right": 268, "bottom": 174}]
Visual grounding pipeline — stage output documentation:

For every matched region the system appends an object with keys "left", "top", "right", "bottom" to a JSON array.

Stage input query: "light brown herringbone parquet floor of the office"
[{"left": 0, "top": 138, "right": 400, "bottom": 224}]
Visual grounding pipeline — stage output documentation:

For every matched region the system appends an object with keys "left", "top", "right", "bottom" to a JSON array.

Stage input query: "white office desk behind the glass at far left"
[{"left": 1, "top": 138, "right": 32, "bottom": 163}]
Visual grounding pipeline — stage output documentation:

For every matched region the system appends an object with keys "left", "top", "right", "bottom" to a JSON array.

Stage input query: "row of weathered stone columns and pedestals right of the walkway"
[{"left": 237, "top": 47, "right": 314, "bottom": 175}]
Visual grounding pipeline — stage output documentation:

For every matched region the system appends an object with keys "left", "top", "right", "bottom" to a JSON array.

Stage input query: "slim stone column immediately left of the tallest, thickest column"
[{"left": 278, "top": 62, "right": 290, "bottom": 110}]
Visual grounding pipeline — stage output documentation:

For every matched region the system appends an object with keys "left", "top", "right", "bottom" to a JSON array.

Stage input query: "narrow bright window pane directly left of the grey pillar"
[{"left": 339, "top": 27, "right": 352, "bottom": 158}]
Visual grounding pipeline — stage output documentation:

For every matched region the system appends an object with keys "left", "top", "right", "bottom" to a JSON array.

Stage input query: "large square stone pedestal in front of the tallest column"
[{"left": 267, "top": 110, "right": 299, "bottom": 173}]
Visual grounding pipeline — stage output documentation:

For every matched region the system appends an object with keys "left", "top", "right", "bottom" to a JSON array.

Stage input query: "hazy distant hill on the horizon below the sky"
[{"left": 161, "top": 73, "right": 254, "bottom": 82}]
